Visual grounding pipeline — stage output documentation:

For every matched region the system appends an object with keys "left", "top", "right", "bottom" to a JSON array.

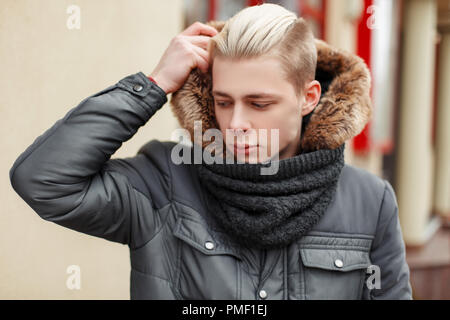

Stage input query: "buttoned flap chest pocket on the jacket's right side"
[{"left": 299, "top": 236, "right": 372, "bottom": 300}]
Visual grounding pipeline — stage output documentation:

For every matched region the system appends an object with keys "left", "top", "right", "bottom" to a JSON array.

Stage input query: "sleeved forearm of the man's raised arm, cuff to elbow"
[{"left": 10, "top": 72, "right": 167, "bottom": 216}]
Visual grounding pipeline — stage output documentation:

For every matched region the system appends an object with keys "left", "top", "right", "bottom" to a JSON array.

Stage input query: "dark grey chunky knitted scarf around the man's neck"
[{"left": 195, "top": 144, "right": 345, "bottom": 249}]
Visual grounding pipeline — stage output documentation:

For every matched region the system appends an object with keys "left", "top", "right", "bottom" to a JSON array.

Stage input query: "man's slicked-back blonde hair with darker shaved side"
[{"left": 208, "top": 3, "right": 317, "bottom": 96}]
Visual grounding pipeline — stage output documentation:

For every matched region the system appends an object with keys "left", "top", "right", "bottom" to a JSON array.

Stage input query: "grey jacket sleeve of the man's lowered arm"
[{"left": 363, "top": 180, "right": 412, "bottom": 300}]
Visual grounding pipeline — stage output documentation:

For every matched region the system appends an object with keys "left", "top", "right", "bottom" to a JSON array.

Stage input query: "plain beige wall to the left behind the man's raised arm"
[{"left": 0, "top": 0, "right": 183, "bottom": 299}]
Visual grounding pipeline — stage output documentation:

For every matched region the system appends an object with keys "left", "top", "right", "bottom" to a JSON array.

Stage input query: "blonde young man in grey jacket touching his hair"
[{"left": 10, "top": 4, "right": 411, "bottom": 299}]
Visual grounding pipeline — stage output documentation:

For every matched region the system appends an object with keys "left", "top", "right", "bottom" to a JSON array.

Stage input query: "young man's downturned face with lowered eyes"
[{"left": 212, "top": 56, "right": 304, "bottom": 163}]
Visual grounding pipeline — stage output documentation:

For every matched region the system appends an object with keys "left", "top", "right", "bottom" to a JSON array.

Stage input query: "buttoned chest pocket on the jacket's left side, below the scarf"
[{"left": 173, "top": 208, "right": 241, "bottom": 300}]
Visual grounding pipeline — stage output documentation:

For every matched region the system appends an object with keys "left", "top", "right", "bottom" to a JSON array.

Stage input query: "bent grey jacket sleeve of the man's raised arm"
[{"left": 9, "top": 72, "right": 171, "bottom": 247}]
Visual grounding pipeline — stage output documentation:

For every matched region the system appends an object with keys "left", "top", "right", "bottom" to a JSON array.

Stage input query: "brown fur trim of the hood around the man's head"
[{"left": 170, "top": 21, "right": 372, "bottom": 152}]
